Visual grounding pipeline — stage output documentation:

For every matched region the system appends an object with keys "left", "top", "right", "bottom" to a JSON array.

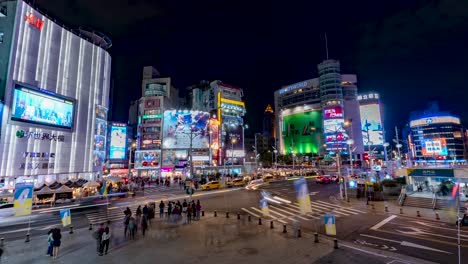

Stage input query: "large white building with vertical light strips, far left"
[{"left": 0, "top": 1, "right": 112, "bottom": 187}]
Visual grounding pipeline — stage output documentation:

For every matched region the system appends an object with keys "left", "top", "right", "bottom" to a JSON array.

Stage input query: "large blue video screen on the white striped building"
[{"left": 11, "top": 85, "right": 75, "bottom": 129}]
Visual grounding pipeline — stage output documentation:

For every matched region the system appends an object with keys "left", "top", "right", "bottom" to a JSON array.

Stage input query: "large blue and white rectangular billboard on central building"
[{"left": 163, "top": 111, "right": 210, "bottom": 149}]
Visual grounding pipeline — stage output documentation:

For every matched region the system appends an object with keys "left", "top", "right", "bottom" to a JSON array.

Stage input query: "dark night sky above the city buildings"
[{"left": 35, "top": 0, "right": 468, "bottom": 136}]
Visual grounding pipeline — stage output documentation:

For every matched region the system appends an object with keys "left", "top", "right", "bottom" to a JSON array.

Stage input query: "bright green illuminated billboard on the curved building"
[{"left": 282, "top": 110, "right": 322, "bottom": 154}]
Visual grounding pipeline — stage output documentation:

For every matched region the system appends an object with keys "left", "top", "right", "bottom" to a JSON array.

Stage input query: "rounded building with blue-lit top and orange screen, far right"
[{"left": 405, "top": 102, "right": 466, "bottom": 166}]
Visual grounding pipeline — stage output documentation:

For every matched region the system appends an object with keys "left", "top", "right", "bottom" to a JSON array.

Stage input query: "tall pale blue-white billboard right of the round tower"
[{"left": 359, "top": 104, "right": 384, "bottom": 145}]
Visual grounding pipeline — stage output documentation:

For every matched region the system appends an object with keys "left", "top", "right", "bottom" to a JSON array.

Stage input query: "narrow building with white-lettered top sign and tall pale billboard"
[{"left": 353, "top": 92, "right": 385, "bottom": 159}]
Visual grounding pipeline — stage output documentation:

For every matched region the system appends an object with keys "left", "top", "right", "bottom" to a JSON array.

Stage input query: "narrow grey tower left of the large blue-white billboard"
[{"left": 136, "top": 66, "right": 179, "bottom": 177}]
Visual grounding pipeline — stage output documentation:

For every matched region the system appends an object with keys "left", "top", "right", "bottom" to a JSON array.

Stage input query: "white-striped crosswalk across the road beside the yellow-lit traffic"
[{"left": 241, "top": 200, "right": 367, "bottom": 224}]
